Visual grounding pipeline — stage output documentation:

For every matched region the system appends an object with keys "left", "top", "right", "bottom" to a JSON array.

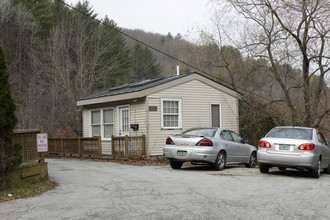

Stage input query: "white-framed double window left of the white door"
[{"left": 91, "top": 108, "right": 113, "bottom": 139}]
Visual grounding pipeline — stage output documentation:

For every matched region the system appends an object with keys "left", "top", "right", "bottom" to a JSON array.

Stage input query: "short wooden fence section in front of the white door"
[{"left": 111, "top": 135, "right": 146, "bottom": 160}]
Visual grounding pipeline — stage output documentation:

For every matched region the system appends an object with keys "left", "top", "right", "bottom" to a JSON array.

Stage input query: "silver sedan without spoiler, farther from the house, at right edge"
[{"left": 257, "top": 126, "right": 330, "bottom": 178}]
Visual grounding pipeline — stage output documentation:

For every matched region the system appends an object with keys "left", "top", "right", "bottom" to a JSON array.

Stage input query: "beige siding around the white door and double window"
[{"left": 83, "top": 99, "right": 146, "bottom": 155}]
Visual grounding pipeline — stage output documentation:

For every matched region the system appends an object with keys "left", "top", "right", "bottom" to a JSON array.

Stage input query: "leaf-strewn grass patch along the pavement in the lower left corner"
[{"left": 0, "top": 180, "right": 58, "bottom": 202}]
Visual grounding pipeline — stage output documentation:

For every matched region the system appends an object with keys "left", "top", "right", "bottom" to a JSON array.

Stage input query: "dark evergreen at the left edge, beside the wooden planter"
[{"left": 0, "top": 40, "right": 21, "bottom": 189}]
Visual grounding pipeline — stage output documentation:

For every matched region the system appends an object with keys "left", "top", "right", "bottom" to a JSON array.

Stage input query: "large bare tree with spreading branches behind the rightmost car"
[{"left": 218, "top": 0, "right": 330, "bottom": 127}]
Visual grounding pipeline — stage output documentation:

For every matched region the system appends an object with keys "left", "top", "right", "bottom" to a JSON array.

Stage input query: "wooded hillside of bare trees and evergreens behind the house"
[{"left": 0, "top": 0, "right": 330, "bottom": 142}]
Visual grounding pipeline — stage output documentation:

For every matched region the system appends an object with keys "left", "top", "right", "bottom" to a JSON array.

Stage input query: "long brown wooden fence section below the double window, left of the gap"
[{"left": 48, "top": 137, "right": 102, "bottom": 156}]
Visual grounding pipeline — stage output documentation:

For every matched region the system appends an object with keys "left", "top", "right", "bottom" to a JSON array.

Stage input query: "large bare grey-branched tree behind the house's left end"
[{"left": 34, "top": 6, "right": 128, "bottom": 135}]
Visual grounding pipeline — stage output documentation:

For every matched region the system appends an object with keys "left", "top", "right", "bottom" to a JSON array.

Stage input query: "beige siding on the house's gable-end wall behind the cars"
[{"left": 148, "top": 80, "right": 238, "bottom": 156}]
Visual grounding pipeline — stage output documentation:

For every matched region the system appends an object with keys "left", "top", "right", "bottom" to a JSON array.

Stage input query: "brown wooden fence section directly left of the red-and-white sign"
[{"left": 13, "top": 128, "right": 43, "bottom": 163}]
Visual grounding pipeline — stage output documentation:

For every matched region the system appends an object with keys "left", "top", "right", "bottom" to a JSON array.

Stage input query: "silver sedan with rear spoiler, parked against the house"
[{"left": 163, "top": 128, "right": 257, "bottom": 170}]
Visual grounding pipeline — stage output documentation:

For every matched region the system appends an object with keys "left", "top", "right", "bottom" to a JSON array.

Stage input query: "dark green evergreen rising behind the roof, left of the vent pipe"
[{"left": 131, "top": 43, "right": 162, "bottom": 81}]
